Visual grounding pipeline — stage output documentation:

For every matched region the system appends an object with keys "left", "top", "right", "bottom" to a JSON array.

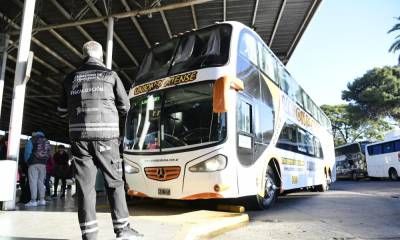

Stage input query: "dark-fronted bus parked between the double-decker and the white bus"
[{"left": 335, "top": 141, "right": 371, "bottom": 181}]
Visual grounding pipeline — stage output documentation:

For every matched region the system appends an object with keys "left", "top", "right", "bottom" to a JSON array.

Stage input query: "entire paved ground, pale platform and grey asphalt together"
[{"left": 0, "top": 181, "right": 400, "bottom": 240}]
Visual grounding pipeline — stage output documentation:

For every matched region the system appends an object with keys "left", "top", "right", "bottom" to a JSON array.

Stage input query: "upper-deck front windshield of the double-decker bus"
[{"left": 135, "top": 24, "right": 232, "bottom": 85}]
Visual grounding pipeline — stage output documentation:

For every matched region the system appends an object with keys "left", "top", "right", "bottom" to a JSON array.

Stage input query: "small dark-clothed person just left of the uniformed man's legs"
[{"left": 52, "top": 145, "right": 70, "bottom": 198}]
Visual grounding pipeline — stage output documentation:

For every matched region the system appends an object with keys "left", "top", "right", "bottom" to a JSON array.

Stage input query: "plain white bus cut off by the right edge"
[{"left": 366, "top": 138, "right": 400, "bottom": 180}]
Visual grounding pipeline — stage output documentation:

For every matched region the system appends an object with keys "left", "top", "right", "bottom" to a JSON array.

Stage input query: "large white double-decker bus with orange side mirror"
[{"left": 124, "top": 22, "right": 335, "bottom": 209}]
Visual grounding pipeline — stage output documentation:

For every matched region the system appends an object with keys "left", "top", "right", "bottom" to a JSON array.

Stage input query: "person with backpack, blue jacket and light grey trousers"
[{"left": 24, "top": 131, "right": 51, "bottom": 207}]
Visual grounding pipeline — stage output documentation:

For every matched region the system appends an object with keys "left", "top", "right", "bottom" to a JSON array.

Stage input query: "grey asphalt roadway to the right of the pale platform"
[{"left": 215, "top": 180, "right": 400, "bottom": 240}]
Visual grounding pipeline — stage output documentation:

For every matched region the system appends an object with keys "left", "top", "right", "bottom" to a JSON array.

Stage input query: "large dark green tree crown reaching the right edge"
[{"left": 342, "top": 66, "right": 400, "bottom": 121}]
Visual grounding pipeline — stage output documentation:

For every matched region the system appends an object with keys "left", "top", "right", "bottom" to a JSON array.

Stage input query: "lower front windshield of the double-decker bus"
[{"left": 125, "top": 82, "right": 226, "bottom": 152}]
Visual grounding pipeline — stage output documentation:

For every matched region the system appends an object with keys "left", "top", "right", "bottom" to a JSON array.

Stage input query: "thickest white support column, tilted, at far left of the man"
[{"left": 2, "top": 0, "right": 36, "bottom": 210}]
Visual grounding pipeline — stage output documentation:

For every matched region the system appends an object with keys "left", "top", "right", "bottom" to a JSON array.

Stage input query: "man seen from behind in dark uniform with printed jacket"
[{"left": 58, "top": 41, "right": 143, "bottom": 240}]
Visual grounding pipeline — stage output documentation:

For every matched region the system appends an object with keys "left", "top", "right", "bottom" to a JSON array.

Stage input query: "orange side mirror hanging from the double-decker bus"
[{"left": 213, "top": 76, "right": 244, "bottom": 113}]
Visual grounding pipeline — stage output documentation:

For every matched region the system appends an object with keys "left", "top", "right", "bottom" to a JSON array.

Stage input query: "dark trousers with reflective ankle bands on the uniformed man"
[{"left": 71, "top": 139, "right": 129, "bottom": 239}]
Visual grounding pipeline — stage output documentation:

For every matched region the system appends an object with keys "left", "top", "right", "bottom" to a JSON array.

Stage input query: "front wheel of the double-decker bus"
[{"left": 248, "top": 166, "right": 279, "bottom": 210}]
